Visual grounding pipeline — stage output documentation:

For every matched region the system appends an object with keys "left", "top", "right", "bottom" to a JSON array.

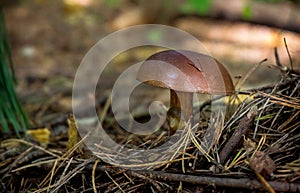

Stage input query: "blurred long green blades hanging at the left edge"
[{"left": 0, "top": 7, "right": 28, "bottom": 137}]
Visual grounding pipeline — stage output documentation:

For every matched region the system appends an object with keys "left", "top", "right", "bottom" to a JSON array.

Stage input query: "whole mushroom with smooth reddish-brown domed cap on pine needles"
[{"left": 137, "top": 50, "right": 234, "bottom": 135}]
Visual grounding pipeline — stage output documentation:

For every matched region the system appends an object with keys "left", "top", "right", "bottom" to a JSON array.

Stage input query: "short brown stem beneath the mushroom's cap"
[{"left": 170, "top": 90, "right": 193, "bottom": 121}]
